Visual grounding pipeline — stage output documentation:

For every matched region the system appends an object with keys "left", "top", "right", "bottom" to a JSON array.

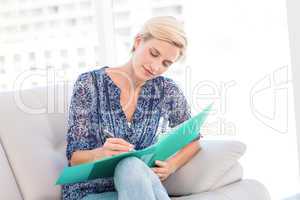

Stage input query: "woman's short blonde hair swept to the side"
[{"left": 131, "top": 16, "right": 187, "bottom": 58}]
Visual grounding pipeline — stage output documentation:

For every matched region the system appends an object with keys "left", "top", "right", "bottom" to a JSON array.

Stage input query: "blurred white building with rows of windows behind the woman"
[{"left": 0, "top": 0, "right": 183, "bottom": 91}]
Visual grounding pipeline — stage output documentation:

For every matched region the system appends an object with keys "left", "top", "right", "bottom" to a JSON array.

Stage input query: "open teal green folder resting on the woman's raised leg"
[{"left": 56, "top": 104, "right": 212, "bottom": 185}]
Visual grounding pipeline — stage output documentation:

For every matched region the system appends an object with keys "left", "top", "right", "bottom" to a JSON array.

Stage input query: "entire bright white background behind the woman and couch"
[{"left": 0, "top": 0, "right": 300, "bottom": 199}]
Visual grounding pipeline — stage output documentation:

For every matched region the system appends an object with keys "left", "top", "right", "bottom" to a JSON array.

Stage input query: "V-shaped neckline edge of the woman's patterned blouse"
[{"left": 103, "top": 67, "right": 149, "bottom": 128}]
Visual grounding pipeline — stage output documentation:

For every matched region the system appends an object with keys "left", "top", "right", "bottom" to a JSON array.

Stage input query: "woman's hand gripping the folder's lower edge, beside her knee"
[{"left": 151, "top": 160, "right": 175, "bottom": 181}]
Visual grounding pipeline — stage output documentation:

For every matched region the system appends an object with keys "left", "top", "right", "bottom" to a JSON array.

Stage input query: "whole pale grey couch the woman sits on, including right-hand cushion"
[{"left": 0, "top": 85, "right": 270, "bottom": 200}]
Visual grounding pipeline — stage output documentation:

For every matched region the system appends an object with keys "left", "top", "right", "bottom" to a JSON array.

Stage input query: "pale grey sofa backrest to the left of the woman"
[{"left": 0, "top": 85, "right": 72, "bottom": 200}]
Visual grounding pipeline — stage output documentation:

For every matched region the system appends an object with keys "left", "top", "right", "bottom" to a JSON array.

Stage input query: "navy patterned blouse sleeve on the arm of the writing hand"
[{"left": 66, "top": 73, "right": 97, "bottom": 161}]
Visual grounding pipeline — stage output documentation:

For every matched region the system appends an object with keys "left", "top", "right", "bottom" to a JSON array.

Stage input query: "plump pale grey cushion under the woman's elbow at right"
[{"left": 163, "top": 140, "right": 246, "bottom": 195}]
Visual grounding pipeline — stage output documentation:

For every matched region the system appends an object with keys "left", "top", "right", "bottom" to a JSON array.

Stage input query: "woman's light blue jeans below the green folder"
[{"left": 82, "top": 157, "right": 170, "bottom": 200}]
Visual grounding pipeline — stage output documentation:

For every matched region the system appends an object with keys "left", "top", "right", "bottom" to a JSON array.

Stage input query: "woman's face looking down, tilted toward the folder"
[{"left": 132, "top": 36, "right": 180, "bottom": 81}]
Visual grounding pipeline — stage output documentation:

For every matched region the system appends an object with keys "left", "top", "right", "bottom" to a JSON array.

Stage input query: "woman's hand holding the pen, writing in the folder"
[{"left": 92, "top": 138, "right": 134, "bottom": 160}]
